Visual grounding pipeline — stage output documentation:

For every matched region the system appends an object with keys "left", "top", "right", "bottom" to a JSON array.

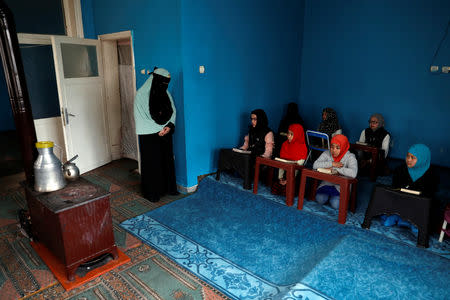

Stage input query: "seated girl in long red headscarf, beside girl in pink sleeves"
[{"left": 272, "top": 124, "right": 308, "bottom": 195}]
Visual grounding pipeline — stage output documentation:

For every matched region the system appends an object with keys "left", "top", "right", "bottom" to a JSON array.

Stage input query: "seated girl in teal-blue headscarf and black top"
[{"left": 381, "top": 144, "right": 438, "bottom": 232}]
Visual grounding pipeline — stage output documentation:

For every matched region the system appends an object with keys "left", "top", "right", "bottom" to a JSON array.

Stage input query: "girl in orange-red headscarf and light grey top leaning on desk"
[{"left": 313, "top": 134, "right": 358, "bottom": 209}]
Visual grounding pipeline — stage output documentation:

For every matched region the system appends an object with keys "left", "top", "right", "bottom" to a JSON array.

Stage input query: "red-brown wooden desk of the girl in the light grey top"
[{"left": 297, "top": 169, "right": 358, "bottom": 224}]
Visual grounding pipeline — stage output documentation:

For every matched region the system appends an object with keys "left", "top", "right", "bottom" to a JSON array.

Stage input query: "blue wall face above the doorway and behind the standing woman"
[{"left": 88, "top": 0, "right": 187, "bottom": 186}]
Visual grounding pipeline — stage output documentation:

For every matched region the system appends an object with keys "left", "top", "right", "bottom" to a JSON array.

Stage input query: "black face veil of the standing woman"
[{"left": 148, "top": 69, "right": 173, "bottom": 125}]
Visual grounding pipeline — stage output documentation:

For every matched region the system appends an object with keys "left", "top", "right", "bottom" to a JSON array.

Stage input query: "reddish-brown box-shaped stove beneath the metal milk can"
[{"left": 24, "top": 178, "right": 118, "bottom": 281}]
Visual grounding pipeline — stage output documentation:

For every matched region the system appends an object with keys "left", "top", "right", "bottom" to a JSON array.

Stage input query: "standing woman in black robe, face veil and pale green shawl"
[{"left": 134, "top": 68, "right": 178, "bottom": 202}]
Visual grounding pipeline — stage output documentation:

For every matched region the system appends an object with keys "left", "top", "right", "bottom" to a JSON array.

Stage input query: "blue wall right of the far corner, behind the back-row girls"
[{"left": 299, "top": 0, "right": 450, "bottom": 166}]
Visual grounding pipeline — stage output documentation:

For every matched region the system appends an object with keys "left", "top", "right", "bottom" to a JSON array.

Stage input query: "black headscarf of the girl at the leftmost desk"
[{"left": 248, "top": 109, "right": 272, "bottom": 155}]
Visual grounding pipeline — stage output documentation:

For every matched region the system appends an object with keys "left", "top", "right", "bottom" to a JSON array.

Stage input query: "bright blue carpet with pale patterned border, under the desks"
[{"left": 121, "top": 178, "right": 450, "bottom": 299}]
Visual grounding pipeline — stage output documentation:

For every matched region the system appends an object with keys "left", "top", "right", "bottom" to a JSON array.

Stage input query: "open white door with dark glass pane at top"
[{"left": 52, "top": 36, "right": 111, "bottom": 173}]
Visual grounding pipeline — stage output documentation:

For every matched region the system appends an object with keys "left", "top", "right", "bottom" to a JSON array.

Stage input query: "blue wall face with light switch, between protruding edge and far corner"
[{"left": 181, "top": 0, "right": 303, "bottom": 186}]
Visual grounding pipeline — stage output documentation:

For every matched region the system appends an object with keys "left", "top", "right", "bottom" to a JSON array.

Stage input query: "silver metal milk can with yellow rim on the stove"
[{"left": 34, "top": 141, "right": 67, "bottom": 192}]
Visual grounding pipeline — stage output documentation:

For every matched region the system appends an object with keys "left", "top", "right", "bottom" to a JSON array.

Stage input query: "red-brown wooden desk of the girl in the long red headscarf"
[{"left": 253, "top": 157, "right": 304, "bottom": 206}]
